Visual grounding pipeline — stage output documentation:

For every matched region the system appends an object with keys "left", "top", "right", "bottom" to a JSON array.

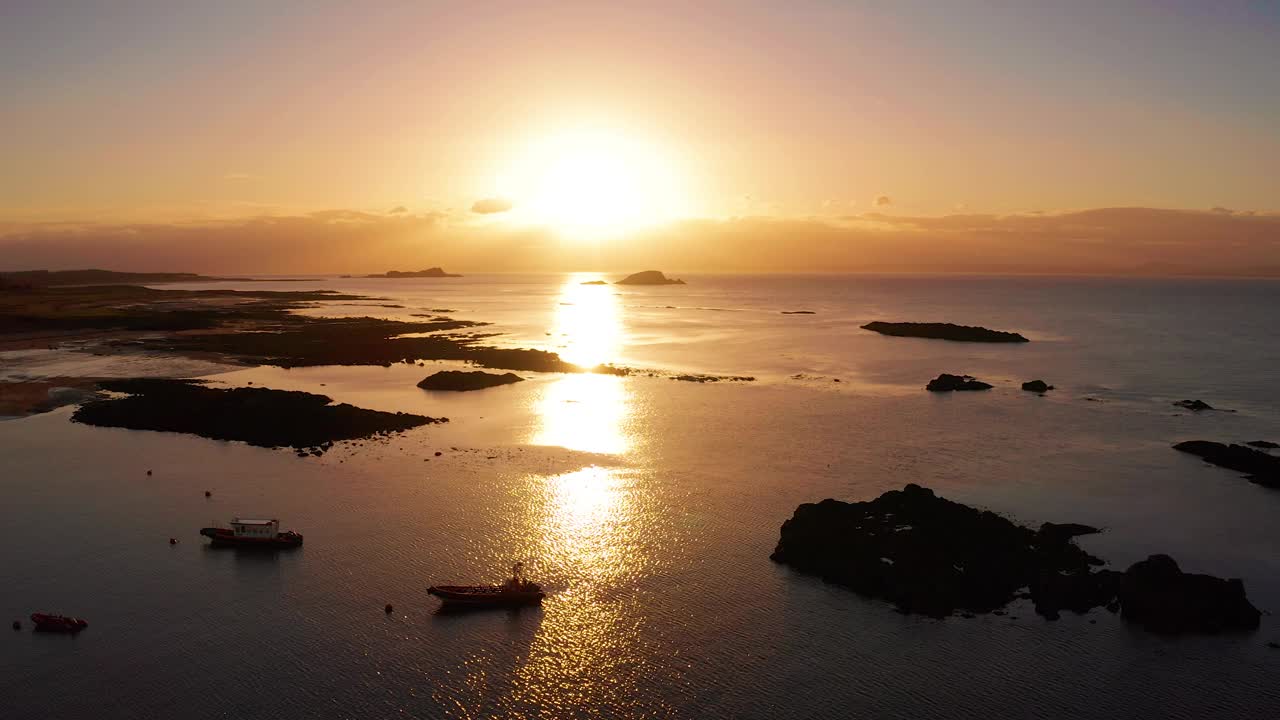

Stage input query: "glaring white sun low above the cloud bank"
[{"left": 499, "top": 127, "right": 690, "bottom": 238}]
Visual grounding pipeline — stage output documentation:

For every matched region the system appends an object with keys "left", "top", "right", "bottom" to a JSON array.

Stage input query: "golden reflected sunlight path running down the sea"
[{"left": 507, "top": 270, "right": 662, "bottom": 716}]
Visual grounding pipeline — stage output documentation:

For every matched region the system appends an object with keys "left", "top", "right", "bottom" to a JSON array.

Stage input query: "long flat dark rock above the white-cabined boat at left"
[{"left": 72, "top": 378, "right": 440, "bottom": 448}]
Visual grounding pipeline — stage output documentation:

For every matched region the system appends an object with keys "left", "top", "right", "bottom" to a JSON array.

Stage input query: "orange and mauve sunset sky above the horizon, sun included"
[{"left": 0, "top": 1, "right": 1280, "bottom": 272}]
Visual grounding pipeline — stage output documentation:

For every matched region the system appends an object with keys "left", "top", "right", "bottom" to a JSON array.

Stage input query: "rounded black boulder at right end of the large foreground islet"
[{"left": 1119, "top": 555, "right": 1261, "bottom": 633}]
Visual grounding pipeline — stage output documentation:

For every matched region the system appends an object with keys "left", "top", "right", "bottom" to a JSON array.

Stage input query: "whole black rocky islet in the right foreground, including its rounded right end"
[{"left": 771, "top": 484, "right": 1261, "bottom": 633}]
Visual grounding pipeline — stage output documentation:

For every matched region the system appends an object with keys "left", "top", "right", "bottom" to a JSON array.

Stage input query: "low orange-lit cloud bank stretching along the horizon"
[{"left": 0, "top": 208, "right": 1280, "bottom": 277}]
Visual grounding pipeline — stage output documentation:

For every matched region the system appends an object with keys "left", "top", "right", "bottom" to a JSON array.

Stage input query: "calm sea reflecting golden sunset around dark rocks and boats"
[{"left": 0, "top": 273, "right": 1280, "bottom": 720}]
